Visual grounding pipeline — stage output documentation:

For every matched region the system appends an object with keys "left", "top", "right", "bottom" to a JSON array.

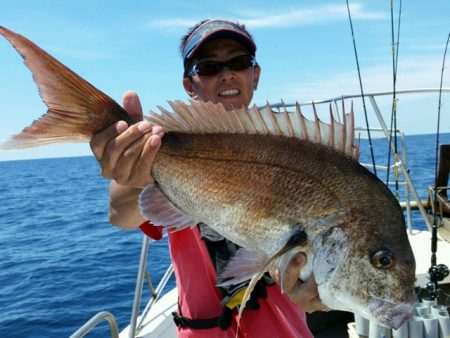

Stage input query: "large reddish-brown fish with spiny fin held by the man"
[{"left": 0, "top": 27, "right": 415, "bottom": 328}]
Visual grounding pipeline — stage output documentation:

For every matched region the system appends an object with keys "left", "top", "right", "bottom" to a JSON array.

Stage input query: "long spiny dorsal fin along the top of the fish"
[{"left": 145, "top": 101, "right": 358, "bottom": 159}]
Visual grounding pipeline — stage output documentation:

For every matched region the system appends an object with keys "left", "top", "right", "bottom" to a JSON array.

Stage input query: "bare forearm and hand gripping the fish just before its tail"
[{"left": 90, "top": 91, "right": 164, "bottom": 229}]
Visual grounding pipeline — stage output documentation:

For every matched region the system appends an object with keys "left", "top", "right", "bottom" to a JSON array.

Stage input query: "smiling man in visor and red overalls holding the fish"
[{"left": 91, "top": 20, "right": 324, "bottom": 338}]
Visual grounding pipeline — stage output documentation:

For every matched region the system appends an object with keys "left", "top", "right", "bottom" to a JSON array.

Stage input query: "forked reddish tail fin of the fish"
[{"left": 0, "top": 26, "right": 133, "bottom": 149}]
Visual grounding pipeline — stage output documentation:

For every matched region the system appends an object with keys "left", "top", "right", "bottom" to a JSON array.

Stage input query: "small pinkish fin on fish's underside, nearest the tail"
[{"left": 139, "top": 184, "right": 193, "bottom": 230}]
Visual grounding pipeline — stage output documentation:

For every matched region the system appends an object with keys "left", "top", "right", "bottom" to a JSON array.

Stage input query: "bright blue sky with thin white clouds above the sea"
[{"left": 0, "top": 0, "right": 450, "bottom": 161}]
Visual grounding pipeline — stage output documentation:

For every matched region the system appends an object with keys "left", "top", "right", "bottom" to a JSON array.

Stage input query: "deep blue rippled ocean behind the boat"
[{"left": 0, "top": 134, "right": 450, "bottom": 338}]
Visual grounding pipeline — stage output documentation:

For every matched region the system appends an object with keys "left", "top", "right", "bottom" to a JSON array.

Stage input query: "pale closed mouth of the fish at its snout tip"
[{"left": 369, "top": 299, "right": 414, "bottom": 330}]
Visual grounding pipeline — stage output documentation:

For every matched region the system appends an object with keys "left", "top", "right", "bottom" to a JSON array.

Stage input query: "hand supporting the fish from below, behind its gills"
[{"left": 271, "top": 253, "right": 328, "bottom": 312}]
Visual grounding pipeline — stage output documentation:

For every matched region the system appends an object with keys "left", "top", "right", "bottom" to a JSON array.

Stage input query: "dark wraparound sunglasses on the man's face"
[{"left": 188, "top": 54, "right": 257, "bottom": 77}]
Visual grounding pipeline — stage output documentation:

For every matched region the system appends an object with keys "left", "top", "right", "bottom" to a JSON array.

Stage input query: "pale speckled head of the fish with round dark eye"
[{"left": 313, "top": 219, "right": 415, "bottom": 329}]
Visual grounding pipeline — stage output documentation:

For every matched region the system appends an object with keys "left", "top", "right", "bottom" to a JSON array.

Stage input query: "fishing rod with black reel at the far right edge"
[{"left": 427, "top": 33, "right": 450, "bottom": 299}]
